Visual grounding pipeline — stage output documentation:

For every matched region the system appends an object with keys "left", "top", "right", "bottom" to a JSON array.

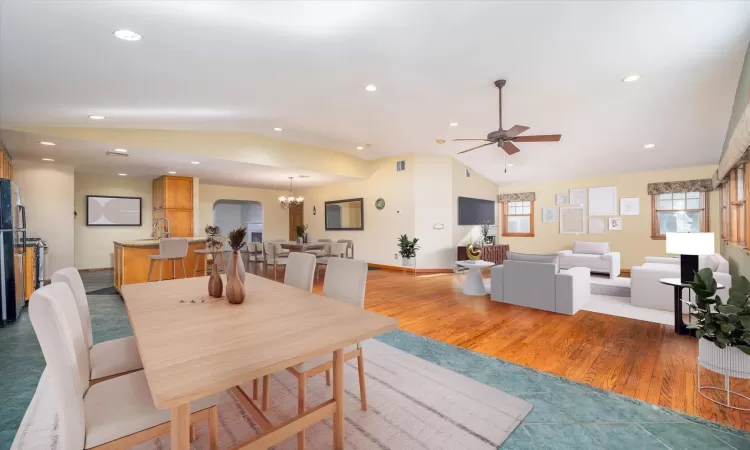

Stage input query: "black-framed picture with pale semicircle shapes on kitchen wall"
[{"left": 86, "top": 195, "right": 143, "bottom": 227}]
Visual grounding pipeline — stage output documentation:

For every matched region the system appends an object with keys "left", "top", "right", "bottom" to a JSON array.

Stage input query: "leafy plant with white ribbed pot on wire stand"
[{"left": 687, "top": 268, "right": 750, "bottom": 411}]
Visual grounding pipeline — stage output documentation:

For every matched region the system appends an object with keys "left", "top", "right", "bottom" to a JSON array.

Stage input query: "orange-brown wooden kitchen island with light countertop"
[{"left": 114, "top": 237, "right": 206, "bottom": 292}]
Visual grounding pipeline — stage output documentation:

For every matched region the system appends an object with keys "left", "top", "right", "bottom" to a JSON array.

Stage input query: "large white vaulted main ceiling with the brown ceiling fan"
[{"left": 0, "top": 0, "right": 750, "bottom": 183}]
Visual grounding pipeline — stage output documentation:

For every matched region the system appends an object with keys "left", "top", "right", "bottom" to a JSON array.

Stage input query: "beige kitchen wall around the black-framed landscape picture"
[{"left": 75, "top": 173, "right": 152, "bottom": 269}]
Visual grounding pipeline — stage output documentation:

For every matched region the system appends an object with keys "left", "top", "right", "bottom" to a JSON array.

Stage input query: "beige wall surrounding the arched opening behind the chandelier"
[{"left": 193, "top": 183, "right": 296, "bottom": 240}]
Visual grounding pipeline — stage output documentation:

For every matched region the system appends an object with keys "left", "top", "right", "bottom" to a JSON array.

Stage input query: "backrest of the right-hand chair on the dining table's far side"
[{"left": 323, "top": 258, "right": 367, "bottom": 308}]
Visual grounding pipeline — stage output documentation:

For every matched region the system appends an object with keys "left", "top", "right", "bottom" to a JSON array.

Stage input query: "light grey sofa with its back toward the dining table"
[{"left": 490, "top": 252, "right": 591, "bottom": 315}]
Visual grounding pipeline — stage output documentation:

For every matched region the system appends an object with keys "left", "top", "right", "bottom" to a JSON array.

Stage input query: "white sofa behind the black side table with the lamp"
[{"left": 630, "top": 253, "right": 732, "bottom": 311}]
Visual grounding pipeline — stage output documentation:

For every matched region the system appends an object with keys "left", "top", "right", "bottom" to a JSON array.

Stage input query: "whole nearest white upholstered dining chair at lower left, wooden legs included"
[{"left": 29, "top": 283, "right": 218, "bottom": 450}]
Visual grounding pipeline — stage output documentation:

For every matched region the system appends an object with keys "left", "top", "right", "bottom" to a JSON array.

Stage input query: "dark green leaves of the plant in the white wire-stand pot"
[{"left": 688, "top": 268, "right": 750, "bottom": 355}]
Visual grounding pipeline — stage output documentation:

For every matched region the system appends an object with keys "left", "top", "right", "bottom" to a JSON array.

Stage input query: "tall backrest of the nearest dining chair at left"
[{"left": 29, "top": 283, "right": 89, "bottom": 449}]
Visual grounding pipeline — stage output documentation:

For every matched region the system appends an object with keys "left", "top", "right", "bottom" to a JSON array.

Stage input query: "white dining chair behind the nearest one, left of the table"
[{"left": 52, "top": 267, "right": 143, "bottom": 383}]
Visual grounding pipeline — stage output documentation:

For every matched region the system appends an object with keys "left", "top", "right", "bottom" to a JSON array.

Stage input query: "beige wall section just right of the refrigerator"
[{"left": 13, "top": 159, "right": 75, "bottom": 279}]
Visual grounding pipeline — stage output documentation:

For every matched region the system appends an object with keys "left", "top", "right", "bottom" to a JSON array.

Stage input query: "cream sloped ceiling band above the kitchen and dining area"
[{"left": 0, "top": 130, "right": 350, "bottom": 190}]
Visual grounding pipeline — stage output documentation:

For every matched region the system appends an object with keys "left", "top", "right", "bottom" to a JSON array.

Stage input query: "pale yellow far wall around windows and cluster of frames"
[{"left": 498, "top": 165, "right": 720, "bottom": 269}]
